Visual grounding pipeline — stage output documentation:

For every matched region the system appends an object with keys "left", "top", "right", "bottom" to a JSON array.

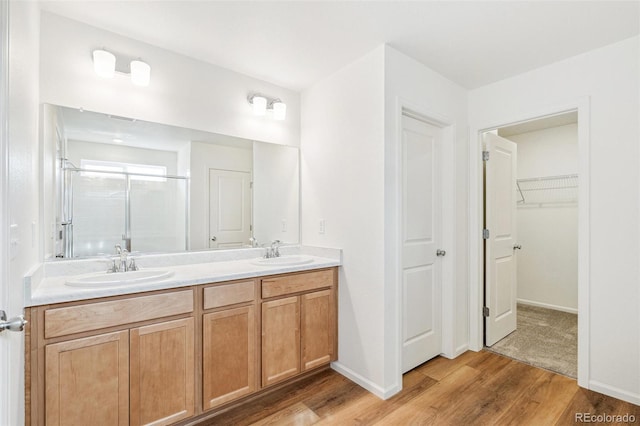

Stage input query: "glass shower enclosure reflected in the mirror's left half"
[{"left": 58, "top": 160, "right": 189, "bottom": 257}]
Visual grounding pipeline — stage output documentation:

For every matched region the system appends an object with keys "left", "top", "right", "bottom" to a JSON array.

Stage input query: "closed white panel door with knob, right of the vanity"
[{"left": 401, "top": 116, "right": 442, "bottom": 373}]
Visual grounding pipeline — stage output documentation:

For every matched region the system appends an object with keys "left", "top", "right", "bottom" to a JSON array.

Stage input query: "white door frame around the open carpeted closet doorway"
[{"left": 469, "top": 97, "right": 591, "bottom": 388}]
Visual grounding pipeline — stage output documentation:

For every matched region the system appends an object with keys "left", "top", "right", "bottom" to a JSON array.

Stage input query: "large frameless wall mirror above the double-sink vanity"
[{"left": 41, "top": 104, "right": 300, "bottom": 259}]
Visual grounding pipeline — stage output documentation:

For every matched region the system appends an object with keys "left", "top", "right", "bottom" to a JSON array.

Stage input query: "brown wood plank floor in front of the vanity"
[{"left": 200, "top": 351, "right": 640, "bottom": 426}]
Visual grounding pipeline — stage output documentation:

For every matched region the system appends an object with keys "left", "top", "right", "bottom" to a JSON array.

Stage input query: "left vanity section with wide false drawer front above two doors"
[{"left": 31, "top": 288, "right": 195, "bottom": 426}]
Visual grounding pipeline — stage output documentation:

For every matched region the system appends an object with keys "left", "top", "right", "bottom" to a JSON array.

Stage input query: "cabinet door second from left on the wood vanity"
[{"left": 130, "top": 318, "right": 195, "bottom": 425}]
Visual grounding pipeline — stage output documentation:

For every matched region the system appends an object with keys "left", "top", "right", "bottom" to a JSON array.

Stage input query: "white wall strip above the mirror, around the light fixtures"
[{"left": 40, "top": 12, "right": 300, "bottom": 146}]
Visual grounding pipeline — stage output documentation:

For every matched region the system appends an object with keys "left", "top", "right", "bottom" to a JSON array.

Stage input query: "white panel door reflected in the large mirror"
[{"left": 209, "top": 169, "right": 251, "bottom": 248}]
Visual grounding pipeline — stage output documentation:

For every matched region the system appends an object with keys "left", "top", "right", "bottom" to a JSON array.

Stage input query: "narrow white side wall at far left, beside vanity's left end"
[{"left": 5, "top": 1, "right": 40, "bottom": 425}]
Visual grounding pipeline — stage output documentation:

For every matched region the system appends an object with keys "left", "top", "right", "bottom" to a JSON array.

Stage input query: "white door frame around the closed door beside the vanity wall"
[{"left": 392, "top": 97, "right": 458, "bottom": 396}]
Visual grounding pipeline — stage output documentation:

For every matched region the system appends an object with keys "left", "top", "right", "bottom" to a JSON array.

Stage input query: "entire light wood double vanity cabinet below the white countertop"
[{"left": 26, "top": 268, "right": 337, "bottom": 426}]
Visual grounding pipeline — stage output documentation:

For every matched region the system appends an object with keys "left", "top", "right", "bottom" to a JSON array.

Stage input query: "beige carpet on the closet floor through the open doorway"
[{"left": 487, "top": 304, "right": 578, "bottom": 379}]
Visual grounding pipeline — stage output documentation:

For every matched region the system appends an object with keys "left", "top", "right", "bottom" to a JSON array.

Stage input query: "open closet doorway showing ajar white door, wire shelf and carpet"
[{"left": 484, "top": 112, "right": 579, "bottom": 378}]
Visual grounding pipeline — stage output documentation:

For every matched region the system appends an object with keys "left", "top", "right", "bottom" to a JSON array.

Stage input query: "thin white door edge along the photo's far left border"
[{"left": 0, "top": 1, "right": 9, "bottom": 424}]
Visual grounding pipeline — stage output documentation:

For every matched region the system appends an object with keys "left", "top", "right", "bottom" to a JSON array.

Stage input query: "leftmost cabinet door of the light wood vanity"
[{"left": 45, "top": 331, "right": 129, "bottom": 426}]
